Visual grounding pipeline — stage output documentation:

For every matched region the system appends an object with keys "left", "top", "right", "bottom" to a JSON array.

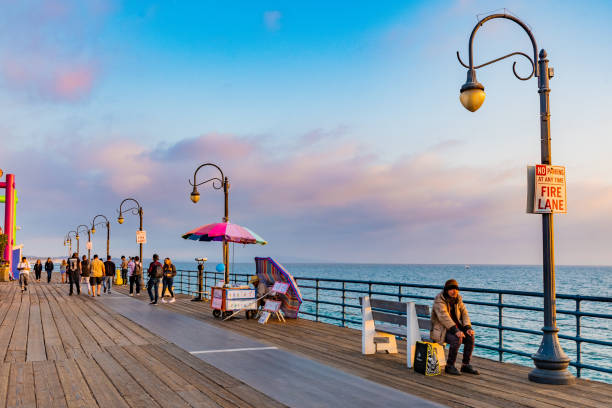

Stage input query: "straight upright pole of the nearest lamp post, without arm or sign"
[{"left": 529, "top": 50, "right": 575, "bottom": 384}]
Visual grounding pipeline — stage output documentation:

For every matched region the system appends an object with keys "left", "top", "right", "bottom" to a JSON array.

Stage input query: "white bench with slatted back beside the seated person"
[{"left": 359, "top": 296, "right": 446, "bottom": 368}]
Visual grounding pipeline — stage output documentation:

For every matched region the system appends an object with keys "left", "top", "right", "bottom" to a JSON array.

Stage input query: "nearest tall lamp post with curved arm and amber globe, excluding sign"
[{"left": 457, "top": 14, "right": 574, "bottom": 384}]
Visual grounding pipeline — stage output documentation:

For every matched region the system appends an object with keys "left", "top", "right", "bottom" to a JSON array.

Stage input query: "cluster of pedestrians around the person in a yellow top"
[{"left": 65, "top": 252, "right": 115, "bottom": 296}]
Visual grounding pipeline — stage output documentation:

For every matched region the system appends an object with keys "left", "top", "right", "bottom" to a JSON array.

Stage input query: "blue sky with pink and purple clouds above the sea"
[{"left": 0, "top": 0, "right": 612, "bottom": 265}]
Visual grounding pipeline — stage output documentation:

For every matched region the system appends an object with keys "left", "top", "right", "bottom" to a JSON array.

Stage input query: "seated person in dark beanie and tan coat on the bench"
[{"left": 430, "top": 279, "right": 479, "bottom": 375}]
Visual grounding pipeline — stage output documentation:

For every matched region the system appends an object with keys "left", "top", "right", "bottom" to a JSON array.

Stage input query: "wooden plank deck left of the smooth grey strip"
[{"left": 0, "top": 276, "right": 284, "bottom": 408}]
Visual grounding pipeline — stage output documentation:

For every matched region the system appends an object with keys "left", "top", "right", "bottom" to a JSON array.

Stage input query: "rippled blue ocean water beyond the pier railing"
[{"left": 177, "top": 261, "right": 612, "bottom": 383}]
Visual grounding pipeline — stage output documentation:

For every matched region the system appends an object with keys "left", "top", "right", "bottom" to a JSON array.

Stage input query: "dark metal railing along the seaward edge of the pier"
[{"left": 175, "top": 270, "right": 612, "bottom": 377}]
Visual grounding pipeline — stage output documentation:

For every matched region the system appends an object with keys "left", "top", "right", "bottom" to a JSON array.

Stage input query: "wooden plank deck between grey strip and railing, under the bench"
[{"left": 116, "top": 287, "right": 612, "bottom": 408}]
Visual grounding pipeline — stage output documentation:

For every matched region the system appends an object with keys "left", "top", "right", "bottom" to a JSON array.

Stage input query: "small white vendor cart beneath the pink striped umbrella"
[{"left": 210, "top": 286, "right": 257, "bottom": 319}]
